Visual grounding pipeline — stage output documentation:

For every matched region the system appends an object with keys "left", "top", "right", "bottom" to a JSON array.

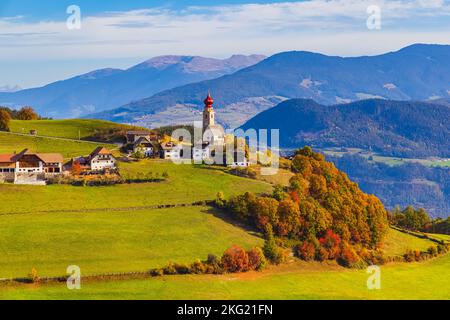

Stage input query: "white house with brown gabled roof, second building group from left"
[{"left": 64, "top": 147, "right": 117, "bottom": 173}]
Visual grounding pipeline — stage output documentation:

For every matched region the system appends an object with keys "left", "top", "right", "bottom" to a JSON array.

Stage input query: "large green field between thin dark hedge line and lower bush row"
[{"left": 0, "top": 207, "right": 263, "bottom": 278}]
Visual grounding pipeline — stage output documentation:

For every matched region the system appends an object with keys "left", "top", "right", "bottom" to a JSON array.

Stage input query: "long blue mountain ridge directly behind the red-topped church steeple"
[{"left": 92, "top": 44, "right": 450, "bottom": 127}]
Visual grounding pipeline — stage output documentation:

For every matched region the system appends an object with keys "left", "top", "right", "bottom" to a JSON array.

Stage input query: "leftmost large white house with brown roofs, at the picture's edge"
[{"left": 0, "top": 149, "right": 64, "bottom": 184}]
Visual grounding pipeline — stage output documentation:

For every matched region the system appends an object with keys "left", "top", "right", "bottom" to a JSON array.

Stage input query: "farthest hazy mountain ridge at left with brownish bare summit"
[{"left": 0, "top": 55, "right": 265, "bottom": 118}]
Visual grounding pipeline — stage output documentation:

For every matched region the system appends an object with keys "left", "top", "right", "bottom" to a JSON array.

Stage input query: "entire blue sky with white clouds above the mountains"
[{"left": 0, "top": 0, "right": 450, "bottom": 88}]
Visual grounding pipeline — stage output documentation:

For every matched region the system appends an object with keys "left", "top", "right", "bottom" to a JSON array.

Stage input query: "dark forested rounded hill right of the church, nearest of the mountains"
[{"left": 242, "top": 99, "right": 450, "bottom": 158}]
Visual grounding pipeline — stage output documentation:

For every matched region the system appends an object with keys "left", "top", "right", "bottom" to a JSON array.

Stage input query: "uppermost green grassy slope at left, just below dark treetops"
[{"left": 10, "top": 119, "right": 132, "bottom": 139}]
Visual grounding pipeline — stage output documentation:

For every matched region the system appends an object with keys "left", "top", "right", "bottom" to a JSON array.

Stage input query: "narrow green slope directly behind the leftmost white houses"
[{"left": 0, "top": 132, "right": 112, "bottom": 159}]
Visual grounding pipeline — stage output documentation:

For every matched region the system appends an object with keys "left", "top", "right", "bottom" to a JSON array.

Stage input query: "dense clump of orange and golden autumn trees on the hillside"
[{"left": 217, "top": 147, "right": 389, "bottom": 267}]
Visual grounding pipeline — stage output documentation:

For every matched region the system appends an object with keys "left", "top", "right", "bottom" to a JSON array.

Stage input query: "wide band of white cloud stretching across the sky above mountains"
[{"left": 0, "top": 0, "right": 450, "bottom": 59}]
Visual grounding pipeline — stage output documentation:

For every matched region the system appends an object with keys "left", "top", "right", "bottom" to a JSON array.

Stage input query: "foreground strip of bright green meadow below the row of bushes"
[{"left": 0, "top": 249, "right": 450, "bottom": 300}]
